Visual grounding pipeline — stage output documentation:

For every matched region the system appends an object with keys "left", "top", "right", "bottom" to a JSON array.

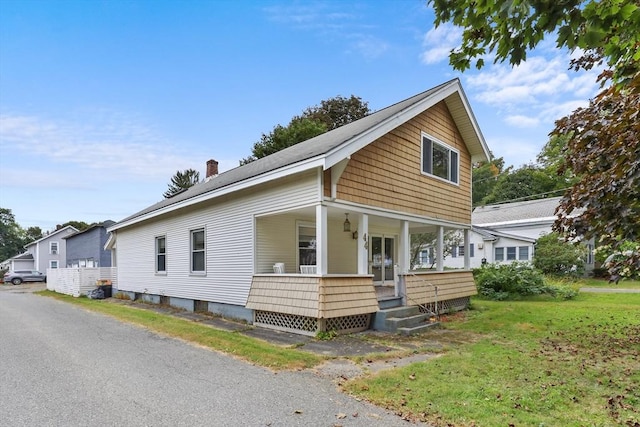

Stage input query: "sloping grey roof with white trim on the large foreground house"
[{"left": 109, "top": 79, "right": 490, "bottom": 231}]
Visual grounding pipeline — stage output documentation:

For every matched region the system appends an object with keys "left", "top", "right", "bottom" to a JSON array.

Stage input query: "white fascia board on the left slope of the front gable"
[{"left": 325, "top": 82, "right": 460, "bottom": 169}]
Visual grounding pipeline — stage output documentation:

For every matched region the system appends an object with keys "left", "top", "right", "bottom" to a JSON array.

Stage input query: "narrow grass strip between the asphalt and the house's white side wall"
[{"left": 38, "top": 291, "right": 324, "bottom": 370}]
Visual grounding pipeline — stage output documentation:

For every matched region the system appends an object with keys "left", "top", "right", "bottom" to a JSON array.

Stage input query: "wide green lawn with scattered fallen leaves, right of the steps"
[{"left": 345, "top": 293, "right": 640, "bottom": 426}]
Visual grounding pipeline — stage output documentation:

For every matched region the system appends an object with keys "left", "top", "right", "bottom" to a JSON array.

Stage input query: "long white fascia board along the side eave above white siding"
[{"left": 107, "top": 156, "right": 325, "bottom": 232}]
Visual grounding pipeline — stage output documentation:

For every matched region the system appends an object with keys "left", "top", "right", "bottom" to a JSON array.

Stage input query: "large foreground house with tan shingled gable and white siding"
[{"left": 107, "top": 79, "right": 489, "bottom": 334}]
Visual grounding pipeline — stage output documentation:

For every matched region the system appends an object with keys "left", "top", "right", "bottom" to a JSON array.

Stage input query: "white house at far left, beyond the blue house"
[{"left": 3, "top": 225, "right": 78, "bottom": 273}]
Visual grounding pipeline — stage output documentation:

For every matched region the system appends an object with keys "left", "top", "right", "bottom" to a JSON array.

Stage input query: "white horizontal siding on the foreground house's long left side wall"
[{"left": 117, "top": 171, "right": 319, "bottom": 306}]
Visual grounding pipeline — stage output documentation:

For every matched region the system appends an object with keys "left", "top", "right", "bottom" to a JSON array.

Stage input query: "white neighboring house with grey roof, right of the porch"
[{"left": 445, "top": 197, "right": 594, "bottom": 271}]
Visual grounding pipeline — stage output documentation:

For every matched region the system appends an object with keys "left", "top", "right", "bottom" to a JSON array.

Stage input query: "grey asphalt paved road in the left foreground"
[{"left": 0, "top": 285, "right": 420, "bottom": 427}]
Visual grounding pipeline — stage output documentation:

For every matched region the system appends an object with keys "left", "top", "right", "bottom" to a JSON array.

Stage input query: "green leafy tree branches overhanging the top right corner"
[{"left": 427, "top": 0, "right": 640, "bottom": 84}]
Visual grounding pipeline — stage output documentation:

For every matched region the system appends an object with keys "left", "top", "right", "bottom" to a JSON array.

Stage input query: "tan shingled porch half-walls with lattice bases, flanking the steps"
[{"left": 246, "top": 270, "right": 476, "bottom": 336}]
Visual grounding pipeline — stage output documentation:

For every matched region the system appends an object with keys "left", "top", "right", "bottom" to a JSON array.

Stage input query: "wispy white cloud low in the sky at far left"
[{"left": 0, "top": 111, "right": 203, "bottom": 180}]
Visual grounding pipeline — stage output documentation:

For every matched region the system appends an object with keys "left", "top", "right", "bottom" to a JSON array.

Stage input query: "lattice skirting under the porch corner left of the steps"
[{"left": 253, "top": 310, "right": 371, "bottom": 336}]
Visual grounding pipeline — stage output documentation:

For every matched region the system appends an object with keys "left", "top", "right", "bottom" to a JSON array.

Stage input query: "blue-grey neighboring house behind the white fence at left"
[{"left": 65, "top": 220, "right": 115, "bottom": 268}]
